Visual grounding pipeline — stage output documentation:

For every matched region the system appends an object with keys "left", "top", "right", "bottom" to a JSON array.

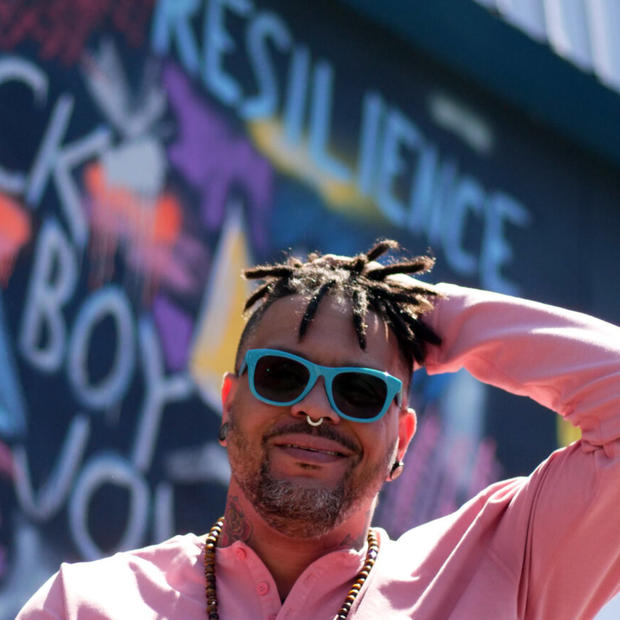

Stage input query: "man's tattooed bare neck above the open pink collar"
[{"left": 219, "top": 482, "right": 372, "bottom": 600}]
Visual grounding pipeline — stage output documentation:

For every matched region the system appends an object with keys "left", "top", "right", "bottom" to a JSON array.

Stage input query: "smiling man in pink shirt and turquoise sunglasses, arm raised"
[{"left": 18, "top": 241, "right": 620, "bottom": 620}]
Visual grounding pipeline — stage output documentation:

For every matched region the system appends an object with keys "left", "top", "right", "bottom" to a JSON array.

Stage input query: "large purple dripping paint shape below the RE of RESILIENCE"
[{"left": 163, "top": 63, "right": 273, "bottom": 249}]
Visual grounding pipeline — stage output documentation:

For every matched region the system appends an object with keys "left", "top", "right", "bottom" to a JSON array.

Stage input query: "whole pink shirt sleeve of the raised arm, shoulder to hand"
[{"left": 427, "top": 284, "right": 620, "bottom": 618}]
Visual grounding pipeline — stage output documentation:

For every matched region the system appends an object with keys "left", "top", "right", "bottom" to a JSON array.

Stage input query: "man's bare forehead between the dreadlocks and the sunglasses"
[{"left": 246, "top": 295, "right": 403, "bottom": 376}]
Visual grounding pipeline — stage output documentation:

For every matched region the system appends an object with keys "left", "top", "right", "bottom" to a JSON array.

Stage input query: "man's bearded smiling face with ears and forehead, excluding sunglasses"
[{"left": 224, "top": 296, "right": 414, "bottom": 537}]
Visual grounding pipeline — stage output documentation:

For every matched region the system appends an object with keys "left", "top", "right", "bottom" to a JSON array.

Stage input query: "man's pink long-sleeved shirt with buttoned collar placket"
[{"left": 18, "top": 285, "right": 620, "bottom": 620}]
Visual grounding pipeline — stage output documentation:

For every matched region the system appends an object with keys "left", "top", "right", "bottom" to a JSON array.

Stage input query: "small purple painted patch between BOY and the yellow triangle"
[{"left": 153, "top": 294, "right": 194, "bottom": 371}]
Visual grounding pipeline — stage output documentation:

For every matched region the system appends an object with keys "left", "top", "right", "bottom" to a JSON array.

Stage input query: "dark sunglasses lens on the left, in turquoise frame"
[{"left": 254, "top": 355, "right": 310, "bottom": 403}]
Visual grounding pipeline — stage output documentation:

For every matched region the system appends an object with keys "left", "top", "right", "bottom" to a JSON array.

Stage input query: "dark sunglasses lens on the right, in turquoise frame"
[{"left": 332, "top": 372, "right": 387, "bottom": 420}]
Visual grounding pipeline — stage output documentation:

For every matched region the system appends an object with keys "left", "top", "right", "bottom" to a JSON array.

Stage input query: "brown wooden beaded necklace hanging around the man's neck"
[{"left": 204, "top": 517, "right": 379, "bottom": 620}]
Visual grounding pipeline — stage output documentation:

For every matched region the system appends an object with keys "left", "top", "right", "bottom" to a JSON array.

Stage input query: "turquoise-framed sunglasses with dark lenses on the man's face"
[{"left": 239, "top": 349, "right": 403, "bottom": 422}]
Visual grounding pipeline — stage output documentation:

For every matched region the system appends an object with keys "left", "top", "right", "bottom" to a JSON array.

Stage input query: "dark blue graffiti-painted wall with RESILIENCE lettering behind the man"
[{"left": 0, "top": 0, "right": 620, "bottom": 618}]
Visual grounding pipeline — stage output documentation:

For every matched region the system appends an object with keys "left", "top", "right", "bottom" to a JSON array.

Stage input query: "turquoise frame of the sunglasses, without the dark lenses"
[{"left": 239, "top": 349, "right": 403, "bottom": 423}]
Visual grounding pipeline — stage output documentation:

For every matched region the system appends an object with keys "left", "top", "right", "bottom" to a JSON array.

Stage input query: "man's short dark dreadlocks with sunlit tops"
[{"left": 237, "top": 239, "right": 441, "bottom": 368}]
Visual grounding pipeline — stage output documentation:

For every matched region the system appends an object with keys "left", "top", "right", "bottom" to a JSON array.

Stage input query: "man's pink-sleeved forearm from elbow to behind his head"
[{"left": 426, "top": 284, "right": 620, "bottom": 446}]
